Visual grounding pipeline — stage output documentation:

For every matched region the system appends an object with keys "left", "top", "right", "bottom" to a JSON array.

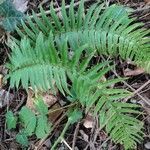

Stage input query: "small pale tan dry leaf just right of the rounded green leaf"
[{"left": 83, "top": 114, "right": 94, "bottom": 129}]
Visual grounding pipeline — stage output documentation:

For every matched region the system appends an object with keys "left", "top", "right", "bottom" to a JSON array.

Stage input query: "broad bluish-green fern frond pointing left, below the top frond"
[{"left": 7, "top": 33, "right": 91, "bottom": 94}]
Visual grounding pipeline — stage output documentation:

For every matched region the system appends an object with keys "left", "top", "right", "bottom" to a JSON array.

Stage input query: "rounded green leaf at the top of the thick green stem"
[{"left": 68, "top": 109, "right": 82, "bottom": 124}]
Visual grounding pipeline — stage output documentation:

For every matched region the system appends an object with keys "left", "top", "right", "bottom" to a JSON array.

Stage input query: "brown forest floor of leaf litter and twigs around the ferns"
[{"left": 0, "top": 0, "right": 150, "bottom": 150}]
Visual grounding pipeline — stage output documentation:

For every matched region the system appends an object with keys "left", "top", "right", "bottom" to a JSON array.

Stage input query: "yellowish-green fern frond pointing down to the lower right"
[{"left": 70, "top": 71, "right": 143, "bottom": 149}]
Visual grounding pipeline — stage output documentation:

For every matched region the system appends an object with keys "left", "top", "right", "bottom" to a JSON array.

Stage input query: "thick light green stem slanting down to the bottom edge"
[{"left": 51, "top": 119, "right": 71, "bottom": 150}]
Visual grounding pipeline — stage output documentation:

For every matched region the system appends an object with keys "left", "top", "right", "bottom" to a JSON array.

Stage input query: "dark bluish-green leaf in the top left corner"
[{"left": 0, "top": 0, "right": 24, "bottom": 31}]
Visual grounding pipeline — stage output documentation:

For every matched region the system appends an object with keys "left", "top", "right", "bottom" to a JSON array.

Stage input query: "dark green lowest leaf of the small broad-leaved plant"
[{"left": 16, "top": 131, "right": 29, "bottom": 147}]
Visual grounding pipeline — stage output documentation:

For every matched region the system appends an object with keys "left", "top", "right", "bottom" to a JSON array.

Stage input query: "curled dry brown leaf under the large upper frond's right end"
[{"left": 124, "top": 68, "right": 144, "bottom": 77}]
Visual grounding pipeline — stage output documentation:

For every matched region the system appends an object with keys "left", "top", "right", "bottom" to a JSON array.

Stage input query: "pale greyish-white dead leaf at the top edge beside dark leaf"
[{"left": 13, "top": 0, "right": 28, "bottom": 13}]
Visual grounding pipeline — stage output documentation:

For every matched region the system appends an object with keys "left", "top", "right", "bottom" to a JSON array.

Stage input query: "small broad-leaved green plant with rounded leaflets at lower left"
[{"left": 6, "top": 97, "right": 51, "bottom": 146}]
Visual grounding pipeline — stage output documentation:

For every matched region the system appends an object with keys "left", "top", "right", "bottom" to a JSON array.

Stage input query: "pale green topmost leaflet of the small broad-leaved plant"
[{"left": 35, "top": 97, "right": 48, "bottom": 115}]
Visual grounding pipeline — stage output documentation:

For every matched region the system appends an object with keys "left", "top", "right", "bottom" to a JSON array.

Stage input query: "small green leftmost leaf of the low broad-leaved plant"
[{"left": 6, "top": 111, "right": 17, "bottom": 130}]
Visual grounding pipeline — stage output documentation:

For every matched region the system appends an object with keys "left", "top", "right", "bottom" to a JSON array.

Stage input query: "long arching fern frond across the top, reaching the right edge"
[{"left": 17, "top": 0, "right": 150, "bottom": 72}]
